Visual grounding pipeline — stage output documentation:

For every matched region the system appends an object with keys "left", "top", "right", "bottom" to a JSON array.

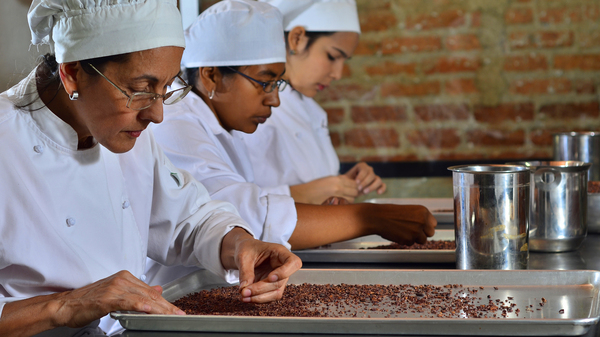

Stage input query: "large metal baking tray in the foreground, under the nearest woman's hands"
[{"left": 111, "top": 269, "right": 600, "bottom": 336}]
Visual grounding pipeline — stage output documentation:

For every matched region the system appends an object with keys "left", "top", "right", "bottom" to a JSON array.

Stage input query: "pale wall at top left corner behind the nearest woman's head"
[{"left": 0, "top": 0, "right": 49, "bottom": 92}]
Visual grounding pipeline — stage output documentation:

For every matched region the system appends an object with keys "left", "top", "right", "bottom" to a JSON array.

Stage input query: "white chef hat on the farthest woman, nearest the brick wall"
[{"left": 260, "top": 0, "right": 360, "bottom": 34}]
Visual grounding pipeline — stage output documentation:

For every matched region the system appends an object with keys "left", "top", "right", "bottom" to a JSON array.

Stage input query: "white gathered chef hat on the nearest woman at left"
[{"left": 27, "top": 0, "right": 185, "bottom": 63}]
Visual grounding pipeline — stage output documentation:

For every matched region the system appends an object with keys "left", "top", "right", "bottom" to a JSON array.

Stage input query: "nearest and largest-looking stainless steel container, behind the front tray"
[{"left": 448, "top": 165, "right": 530, "bottom": 269}]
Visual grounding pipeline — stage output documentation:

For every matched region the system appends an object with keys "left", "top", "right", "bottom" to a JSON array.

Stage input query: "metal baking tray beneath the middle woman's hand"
[{"left": 294, "top": 229, "right": 456, "bottom": 263}]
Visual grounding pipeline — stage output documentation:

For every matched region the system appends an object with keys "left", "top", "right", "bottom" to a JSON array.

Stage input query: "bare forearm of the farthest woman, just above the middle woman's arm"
[{"left": 290, "top": 174, "right": 359, "bottom": 205}]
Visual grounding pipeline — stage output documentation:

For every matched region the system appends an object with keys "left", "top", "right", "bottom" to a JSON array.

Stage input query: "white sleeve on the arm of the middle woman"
[{"left": 155, "top": 113, "right": 297, "bottom": 248}]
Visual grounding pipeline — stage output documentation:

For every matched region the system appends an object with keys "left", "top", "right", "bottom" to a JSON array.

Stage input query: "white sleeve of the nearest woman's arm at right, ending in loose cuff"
[{"left": 148, "top": 131, "right": 253, "bottom": 281}]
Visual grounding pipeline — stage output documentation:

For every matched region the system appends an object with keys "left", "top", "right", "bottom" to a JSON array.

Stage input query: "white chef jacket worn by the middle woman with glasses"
[{"left": 153, "top": 92, "right": 297, "bottom": 248}]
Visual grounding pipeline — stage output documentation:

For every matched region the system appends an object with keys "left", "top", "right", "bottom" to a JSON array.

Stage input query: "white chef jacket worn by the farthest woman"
[{"left": 243, "top": 85, "right": 340, "bottom": 195}]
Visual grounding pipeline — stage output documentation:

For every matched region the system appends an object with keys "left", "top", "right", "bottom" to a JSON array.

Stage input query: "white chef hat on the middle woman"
[{"left": 181, "top": 0, "right": 286, "bottom": 68}]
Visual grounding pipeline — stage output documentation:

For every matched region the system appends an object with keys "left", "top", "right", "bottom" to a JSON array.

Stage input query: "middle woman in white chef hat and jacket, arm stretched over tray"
[{"left": 154, "top": 0, "right": 436, "bottom": 260}]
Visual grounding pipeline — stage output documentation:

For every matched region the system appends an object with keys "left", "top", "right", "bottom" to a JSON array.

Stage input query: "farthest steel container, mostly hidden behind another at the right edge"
[{"left": 553, "top": 132, "right": 600, "bottom": 181}]
